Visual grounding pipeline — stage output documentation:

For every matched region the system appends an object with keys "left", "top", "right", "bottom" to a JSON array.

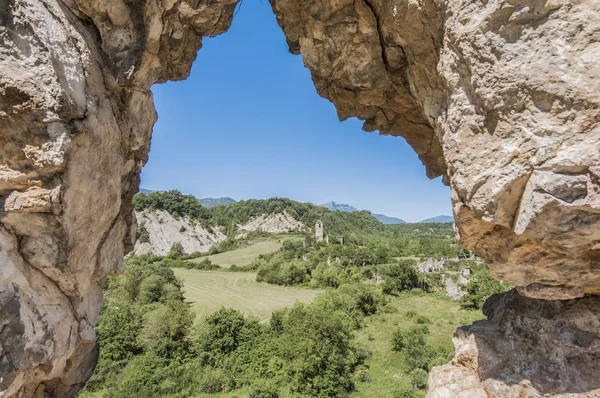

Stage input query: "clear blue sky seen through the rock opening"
[{"left": 141, "top": 0, "right": 452, "bottom": 221}]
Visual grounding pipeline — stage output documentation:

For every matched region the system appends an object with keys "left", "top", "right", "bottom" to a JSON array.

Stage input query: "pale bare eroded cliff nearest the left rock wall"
[{"left": 134, "top": 210, "right": 227, "bottom": 256}]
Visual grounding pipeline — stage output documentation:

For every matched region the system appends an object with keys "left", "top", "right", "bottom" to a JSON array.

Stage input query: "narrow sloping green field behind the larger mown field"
[{"left": 189, "top": 235, "right": 302, "bottom": 268}]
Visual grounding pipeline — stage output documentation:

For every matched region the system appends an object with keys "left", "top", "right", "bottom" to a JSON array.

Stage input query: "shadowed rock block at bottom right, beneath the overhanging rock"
[{"left": 427, "top": 290, "right": 600, "bottom": 398}]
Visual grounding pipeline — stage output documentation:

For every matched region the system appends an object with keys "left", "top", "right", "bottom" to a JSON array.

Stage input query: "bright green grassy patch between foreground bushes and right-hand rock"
[{"left": 351, "top": 293, "right": 484, "bottom": 398}]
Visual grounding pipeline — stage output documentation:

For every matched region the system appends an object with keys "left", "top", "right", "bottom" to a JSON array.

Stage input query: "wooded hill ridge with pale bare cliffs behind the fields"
[{"left": 133, "top": 191, "right": 384, "bottom": 255}]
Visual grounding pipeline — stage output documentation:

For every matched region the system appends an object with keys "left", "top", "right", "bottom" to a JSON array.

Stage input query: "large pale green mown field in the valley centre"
[{"left": 173, "top": 268, "right": 320, "bottom": 320}]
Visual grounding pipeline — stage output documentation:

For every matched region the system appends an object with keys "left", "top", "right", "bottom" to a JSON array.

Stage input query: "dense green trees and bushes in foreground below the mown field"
[{"left": 83, "top": 256, "right": 384, "bottom": 398}]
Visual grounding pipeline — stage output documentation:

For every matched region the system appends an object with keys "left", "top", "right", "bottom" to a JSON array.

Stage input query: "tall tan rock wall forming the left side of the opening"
[{"left": 0, "top": 0, "right": 236, "bottom": 398}]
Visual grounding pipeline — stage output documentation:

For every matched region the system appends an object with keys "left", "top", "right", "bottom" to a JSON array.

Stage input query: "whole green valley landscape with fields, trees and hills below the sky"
[{"left": 79, "top": 191, "right": 502, "bottom": 398}]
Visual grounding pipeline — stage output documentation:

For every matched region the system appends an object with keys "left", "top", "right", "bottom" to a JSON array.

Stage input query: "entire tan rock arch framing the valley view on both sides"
[{"left": 0, "top": 0, "right": 600, "bottom": 398}]
